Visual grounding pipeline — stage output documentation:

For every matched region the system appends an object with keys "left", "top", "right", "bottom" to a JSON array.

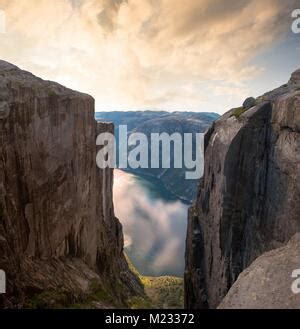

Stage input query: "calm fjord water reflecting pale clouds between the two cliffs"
[{"left": 114, "top": 170, "right": 188, "bottom": 276}]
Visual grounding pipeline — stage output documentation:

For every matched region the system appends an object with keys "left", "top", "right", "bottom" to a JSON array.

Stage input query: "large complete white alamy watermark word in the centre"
[{"left": 96, "top": 125, "right": 204, "bottom": 179}]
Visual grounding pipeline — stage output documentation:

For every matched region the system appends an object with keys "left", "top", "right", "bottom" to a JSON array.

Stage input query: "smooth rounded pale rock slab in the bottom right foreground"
[{"left": 219, "top": 233, "right": 300, "bottom": 309}]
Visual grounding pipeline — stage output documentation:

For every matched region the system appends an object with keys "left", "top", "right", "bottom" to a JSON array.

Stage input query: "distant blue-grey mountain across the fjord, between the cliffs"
[{"left": 96, "top": 111, "right": 219, "bottom": 203}]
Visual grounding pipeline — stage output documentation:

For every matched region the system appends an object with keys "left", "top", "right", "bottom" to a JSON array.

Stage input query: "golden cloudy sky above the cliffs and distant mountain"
[{"left": 0, "top": 0, "right": 300, "bottom": 114}]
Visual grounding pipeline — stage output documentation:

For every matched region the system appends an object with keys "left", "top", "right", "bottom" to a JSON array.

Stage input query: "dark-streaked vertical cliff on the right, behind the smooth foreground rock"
[{"left": 185, "top": 71, "right": 300, "bottom": 308}]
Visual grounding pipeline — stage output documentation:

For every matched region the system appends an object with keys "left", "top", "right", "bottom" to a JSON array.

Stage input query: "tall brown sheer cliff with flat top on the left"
[{"left": 0, "top": 61, "right": 139, "bottom": 307}]
